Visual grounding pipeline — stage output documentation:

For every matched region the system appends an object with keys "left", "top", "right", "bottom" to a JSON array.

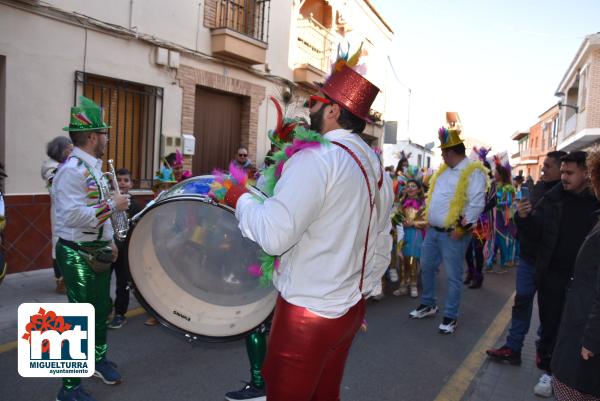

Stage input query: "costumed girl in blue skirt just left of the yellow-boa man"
[{"left": 394, "top": 166, "right": 427, "bottom": 298}]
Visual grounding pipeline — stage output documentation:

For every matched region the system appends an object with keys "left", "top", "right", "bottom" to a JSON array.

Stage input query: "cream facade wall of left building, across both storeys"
[{"left": 0, "top": 0, "right": 292, "bottom": 195}]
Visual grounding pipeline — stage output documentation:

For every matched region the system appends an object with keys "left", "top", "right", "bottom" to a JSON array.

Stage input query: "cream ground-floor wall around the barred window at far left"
[{"left": 0, "top": 5, "right": 181, "bottom": 195}]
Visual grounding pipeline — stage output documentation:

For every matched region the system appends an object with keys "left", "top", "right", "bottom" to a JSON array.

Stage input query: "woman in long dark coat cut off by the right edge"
[{"left": 552, "top": 147, "right": 600, "bottom": 401}]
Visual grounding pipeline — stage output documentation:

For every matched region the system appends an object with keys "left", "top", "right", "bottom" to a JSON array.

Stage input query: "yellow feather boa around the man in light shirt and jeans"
[{"left": 425, "top": 161, "right": 490, "bottom": 228}]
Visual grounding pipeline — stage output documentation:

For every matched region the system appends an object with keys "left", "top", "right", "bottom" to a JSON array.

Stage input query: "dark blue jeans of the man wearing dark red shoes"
[{"left": 506, "top": 258, "right": 537, "bottom": 352}]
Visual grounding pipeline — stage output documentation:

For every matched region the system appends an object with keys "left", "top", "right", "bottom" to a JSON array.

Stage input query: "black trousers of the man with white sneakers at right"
[{"left": 538, "top": 272, "right": 570, "bottom": 372}]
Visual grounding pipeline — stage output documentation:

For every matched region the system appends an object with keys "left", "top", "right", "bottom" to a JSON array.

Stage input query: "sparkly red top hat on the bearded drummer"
[{"left": 321, "top": 65, "right": 379, "bottom": 122}]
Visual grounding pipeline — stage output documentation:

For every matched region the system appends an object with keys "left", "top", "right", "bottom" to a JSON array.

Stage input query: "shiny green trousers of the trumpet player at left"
[{"left": 56, "top": 241, "right": 112, "bottom": 390}]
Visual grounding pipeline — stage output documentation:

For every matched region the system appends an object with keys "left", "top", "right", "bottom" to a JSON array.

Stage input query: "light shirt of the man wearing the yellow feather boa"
[{"left": 427, "top": 158, "right": 485, "bottom": 228}]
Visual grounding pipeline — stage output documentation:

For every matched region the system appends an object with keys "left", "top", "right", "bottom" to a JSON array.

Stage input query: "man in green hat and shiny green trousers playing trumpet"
[{"left": 52, "top": 96, "right": 129, "bottom": 401}]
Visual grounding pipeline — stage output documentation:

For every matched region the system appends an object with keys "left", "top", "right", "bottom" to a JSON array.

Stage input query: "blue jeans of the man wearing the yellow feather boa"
[{"left": 421, "top": 227, "right": 471, "bottom": 319}]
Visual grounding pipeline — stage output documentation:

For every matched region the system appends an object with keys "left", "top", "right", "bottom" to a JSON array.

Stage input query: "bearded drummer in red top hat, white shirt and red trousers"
[{"left": 220, "top": 60, "right": 393, "bottom": 401}]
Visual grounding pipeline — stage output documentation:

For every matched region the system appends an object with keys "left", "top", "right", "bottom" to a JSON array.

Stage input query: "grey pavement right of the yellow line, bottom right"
[{"left": 462, "top": 292, "right": 554, "bottom": 401}]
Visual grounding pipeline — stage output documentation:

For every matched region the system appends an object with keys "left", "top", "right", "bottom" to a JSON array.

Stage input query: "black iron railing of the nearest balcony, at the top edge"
[{"left": 215, "top": 0, "right": 271, "bottom": 43}]
